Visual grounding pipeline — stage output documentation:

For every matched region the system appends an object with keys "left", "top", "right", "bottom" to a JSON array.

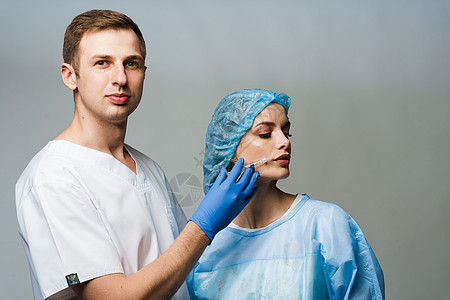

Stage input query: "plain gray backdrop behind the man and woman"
[{"left": 0, "top": 0, "right": 450, "bottom": 299}]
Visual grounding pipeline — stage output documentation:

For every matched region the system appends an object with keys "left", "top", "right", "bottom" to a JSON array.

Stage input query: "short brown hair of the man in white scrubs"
[{"left": 63, "top": 9, "right": 146, "bottom": 76}]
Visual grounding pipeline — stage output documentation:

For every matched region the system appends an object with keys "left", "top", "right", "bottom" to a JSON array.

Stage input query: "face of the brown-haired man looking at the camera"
[{"left": 71, "top": 29, "right": 146, "bottom": 123}]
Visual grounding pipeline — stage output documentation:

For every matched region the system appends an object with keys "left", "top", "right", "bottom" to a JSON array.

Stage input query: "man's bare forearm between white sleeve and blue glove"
[{"left": 72, "top": 222, "right": 210, "bottom": 299}]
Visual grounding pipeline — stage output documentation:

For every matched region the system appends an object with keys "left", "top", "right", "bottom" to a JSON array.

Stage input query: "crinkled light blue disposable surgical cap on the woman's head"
[{"left": 203, "top": 89, "right": 291, "bottom": 194}]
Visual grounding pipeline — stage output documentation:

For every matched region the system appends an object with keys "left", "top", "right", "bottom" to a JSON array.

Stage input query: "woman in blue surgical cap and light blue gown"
[{"left": 188, "top": 90, "right": 384, "bottom": 299}]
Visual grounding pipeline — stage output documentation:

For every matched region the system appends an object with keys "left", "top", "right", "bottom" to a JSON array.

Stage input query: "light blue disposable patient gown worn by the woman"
[{"left": 188, "top": 194, "right": 384, "bottom": 300}]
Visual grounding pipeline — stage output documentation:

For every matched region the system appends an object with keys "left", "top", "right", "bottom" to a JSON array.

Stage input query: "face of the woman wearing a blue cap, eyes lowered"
[{"left": 233, "top": 103, "right": 291, "bottom": 180}]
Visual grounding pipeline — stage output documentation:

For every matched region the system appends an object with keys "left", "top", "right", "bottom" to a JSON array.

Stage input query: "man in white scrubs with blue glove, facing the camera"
[{"left": 16, "top": 10, "right": 258, "bottom": 299}]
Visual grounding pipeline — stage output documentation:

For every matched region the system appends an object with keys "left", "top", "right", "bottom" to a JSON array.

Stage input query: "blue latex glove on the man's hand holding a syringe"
[{"left": 189, "top": 158, "right": 259, "bottom": 241}]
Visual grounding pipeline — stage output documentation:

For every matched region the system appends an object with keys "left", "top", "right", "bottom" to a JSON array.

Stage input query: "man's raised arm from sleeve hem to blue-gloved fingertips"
[{"left": 72, "top": 159, "right": 259, "bottom": 300}]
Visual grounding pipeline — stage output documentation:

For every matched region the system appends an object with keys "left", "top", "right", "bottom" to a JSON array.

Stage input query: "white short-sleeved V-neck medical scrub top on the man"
[{"left": 16, "top": 140, "right": 188, "bottom": 299}]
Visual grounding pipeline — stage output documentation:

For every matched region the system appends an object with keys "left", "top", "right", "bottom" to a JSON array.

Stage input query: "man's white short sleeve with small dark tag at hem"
[{"left": 18, "top": 173, "right": 123, "bottom": 298}]
